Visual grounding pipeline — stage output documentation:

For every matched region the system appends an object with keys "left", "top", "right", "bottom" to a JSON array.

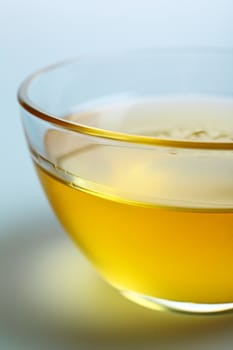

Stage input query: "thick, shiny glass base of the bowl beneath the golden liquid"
[{"left": 120, "top": 291, "right": 233, "bottom": 315}]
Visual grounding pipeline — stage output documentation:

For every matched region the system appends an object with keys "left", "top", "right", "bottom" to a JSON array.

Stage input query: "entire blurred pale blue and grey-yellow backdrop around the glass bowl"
[{"left": 0, "top": 0, "right": 233, "bottom": 350}]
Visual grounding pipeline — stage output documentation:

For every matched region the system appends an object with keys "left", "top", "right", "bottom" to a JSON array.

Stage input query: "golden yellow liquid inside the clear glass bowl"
[{"left": 34, "top": 96, "right": 233, "bottom": 303}]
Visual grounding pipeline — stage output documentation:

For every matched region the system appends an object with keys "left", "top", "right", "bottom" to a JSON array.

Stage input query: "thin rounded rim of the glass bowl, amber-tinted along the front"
[{"left": 17, "top": 47, "right": 233, "bottom": 150}]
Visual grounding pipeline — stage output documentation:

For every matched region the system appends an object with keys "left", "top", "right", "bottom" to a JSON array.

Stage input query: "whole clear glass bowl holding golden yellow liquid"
[{"left": 18, "top": 49, "right": 233, "bottom": 314}]
